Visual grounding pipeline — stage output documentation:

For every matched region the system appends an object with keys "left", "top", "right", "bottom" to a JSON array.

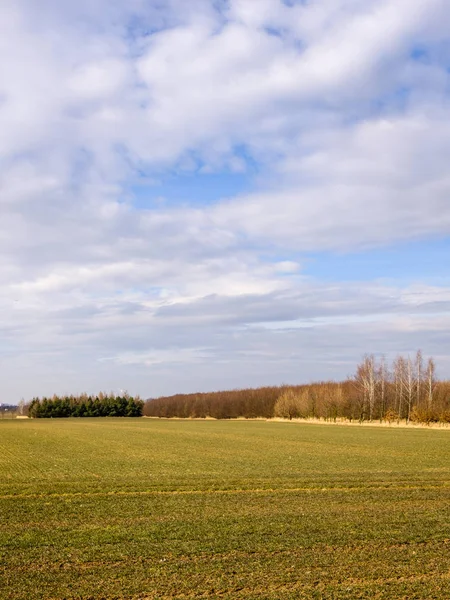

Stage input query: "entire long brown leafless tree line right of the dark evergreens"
[{"left": 144, "top": 351, "right": 450, "bottom": 423}]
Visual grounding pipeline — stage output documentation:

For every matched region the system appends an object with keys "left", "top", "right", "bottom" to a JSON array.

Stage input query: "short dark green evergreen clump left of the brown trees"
[{"left": 27, "top": 393, "right": 144, "bottom": 419}]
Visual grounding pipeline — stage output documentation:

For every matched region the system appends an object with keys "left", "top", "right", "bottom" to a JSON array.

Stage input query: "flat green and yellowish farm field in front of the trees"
[{"left": 0, "top": 419, "right": 450, "bottom": 600}]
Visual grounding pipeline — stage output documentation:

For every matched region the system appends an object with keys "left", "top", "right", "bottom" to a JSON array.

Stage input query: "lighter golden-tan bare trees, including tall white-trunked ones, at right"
[{"left": 274, "top": 350, "right": 450, "bottom": 423}]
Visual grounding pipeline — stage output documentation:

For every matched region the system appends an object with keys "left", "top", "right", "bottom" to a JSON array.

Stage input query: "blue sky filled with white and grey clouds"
[{"left": 0, "top": 0, "right": 450, "bottom": 402}]
